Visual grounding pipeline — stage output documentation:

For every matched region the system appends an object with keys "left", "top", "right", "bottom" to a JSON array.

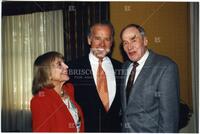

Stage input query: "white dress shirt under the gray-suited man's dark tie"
[{"left": 126, "top": 50, "right": 149, "bottom": 85}]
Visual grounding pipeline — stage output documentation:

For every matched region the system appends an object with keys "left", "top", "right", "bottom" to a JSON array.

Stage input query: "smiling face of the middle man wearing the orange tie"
[{"left": 88, "top": 24, "right": 112, "bottom": 59}]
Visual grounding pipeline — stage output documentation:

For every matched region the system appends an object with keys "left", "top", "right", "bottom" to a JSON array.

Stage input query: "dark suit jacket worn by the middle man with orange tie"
[{"left": 68, "top": 56, "right": 121, "bottom": 132}]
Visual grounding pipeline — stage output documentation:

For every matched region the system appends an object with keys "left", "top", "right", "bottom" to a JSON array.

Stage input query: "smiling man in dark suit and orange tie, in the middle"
[{"left": 68, "top": 22, "right": 121, "bottom": 132}]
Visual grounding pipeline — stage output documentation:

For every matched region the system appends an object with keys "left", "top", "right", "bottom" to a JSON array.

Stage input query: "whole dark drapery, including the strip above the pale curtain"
[{"left": 2, "top": 1, "right": 109, "bottom": 61}]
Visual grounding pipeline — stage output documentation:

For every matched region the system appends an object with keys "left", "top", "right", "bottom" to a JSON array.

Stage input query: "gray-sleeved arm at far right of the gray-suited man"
[{"left": 158, "top": 63, "right": 179, "bottom": 132}]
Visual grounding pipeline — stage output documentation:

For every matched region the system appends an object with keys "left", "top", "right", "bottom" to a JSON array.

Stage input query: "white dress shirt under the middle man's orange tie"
[{"left": 89, "top": 51, "right": 116, "bottom": 108}]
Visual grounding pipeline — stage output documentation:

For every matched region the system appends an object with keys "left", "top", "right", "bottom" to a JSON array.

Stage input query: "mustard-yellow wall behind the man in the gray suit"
[{"left": 110, "top": 2, "right": 192, "bottom": 109}]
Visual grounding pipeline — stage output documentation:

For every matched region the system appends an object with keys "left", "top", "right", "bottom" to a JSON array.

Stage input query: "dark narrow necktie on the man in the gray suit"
[{"left": 126, "top": 62, "right": 139, "bottom": 103}]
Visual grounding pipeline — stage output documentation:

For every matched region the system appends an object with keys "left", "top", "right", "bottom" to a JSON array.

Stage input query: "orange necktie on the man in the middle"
[{"left": 97, "top": 60, "right": 109, "bottom": 111}]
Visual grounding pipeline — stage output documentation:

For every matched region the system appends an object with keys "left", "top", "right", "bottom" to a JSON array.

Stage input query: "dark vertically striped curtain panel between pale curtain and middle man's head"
[{"left": 63, "top": 2, "right": 109, "bottom": 61}]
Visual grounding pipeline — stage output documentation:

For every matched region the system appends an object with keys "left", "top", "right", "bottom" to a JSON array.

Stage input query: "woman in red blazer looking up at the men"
[{"left": 31, "top": 51, "right": 84, "bottom": 132}]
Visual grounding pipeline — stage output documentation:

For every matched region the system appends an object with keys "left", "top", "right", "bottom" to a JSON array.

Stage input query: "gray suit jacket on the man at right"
[{"left": 121, "top": 50, "right": 179, "bottom": 133}]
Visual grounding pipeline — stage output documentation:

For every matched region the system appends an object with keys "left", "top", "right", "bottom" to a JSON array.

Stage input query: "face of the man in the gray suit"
[{"left": 122, "top": 27, "right": 148, "bottom": 62}]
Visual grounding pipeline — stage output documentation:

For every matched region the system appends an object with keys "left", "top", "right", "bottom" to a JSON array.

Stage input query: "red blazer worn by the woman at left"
[{"left": 31, "top": 83, "right": 84, "bottom": 132}]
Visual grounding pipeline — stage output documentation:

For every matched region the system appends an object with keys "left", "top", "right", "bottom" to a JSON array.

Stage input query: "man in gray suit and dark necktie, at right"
[{"left": 120, "top": 24, "right": 179, "bottom": 133}]
